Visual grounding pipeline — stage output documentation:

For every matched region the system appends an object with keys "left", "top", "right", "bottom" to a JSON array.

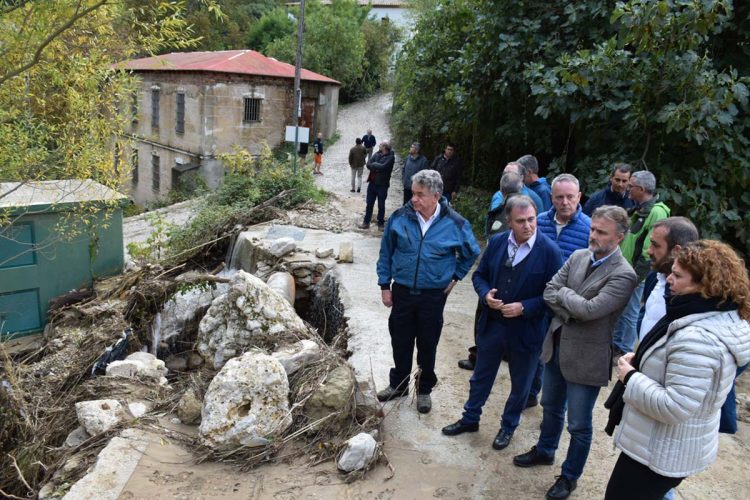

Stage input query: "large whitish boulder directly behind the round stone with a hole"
[{"left": 198, "top": 271, "right": 310, "bottom": 369}]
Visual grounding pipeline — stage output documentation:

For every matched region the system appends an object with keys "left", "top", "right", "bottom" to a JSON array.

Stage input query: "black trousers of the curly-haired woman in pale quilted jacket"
[{"left": 604, "top": 453, "right": 684, "bottom": 500}]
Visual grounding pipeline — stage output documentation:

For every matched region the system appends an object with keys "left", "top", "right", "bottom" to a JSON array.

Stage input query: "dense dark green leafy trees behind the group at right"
[{"left": 393, "top": 0, "right": 750, "bottom": 254}]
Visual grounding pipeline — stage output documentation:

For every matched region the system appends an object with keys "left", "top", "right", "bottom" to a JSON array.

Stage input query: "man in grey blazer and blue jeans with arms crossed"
[{"left": 513, "top": 206, "right": 637, "bottom": 499}]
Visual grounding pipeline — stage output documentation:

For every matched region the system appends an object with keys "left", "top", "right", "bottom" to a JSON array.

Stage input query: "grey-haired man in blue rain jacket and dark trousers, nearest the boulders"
[{"left": 377, "top": 170, "right": 480, "bottom": 413}]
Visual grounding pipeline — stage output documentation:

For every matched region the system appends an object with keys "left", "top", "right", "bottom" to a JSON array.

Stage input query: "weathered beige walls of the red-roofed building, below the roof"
[{"left": 126, "top": 71, "right": 338, "bottom": 203}]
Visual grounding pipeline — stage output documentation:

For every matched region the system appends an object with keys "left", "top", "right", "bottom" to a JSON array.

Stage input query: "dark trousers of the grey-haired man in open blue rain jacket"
[{"left": 388, "top": 283, "right": 447, "bottom": 394}]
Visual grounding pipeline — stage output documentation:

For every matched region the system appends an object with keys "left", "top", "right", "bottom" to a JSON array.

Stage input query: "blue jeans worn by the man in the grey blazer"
[{"left": 536, "top": 346, "right": 601, "bottom": 481}]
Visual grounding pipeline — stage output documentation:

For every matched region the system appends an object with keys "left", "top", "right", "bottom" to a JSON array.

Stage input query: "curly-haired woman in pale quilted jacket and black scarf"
[{"left": 605, "top": 240, "right": 750, "bottom": 500}]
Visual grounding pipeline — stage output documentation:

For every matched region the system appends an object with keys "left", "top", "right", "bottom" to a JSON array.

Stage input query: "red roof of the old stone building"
[{"left": 120, "top": 50, "right": 340, "bottom": 85}]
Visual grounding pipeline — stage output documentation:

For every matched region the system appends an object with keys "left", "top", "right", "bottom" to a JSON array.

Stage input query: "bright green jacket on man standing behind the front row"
[{"left": 620, "top": 196, "right": 670, "bottom": 283}]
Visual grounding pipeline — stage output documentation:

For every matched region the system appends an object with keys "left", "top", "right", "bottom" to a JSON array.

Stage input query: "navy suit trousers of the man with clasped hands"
[{"left": 461, "top": 328, "right": 540, "bottom": 432}]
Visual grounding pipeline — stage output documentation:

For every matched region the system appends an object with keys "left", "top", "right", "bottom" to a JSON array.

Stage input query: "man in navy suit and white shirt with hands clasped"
[{"left": 443, "top": 195, "right": 562, "bottom": 450}]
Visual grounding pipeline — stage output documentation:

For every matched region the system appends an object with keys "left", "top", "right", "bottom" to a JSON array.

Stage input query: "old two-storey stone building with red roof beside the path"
[{"left": 122, "top": 50, "right": 340, "bottom": 203}]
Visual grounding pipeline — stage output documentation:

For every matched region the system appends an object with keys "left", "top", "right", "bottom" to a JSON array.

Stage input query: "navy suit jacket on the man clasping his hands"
[{"left": 472, "top": 231, "right": 563, "bottom": 351}]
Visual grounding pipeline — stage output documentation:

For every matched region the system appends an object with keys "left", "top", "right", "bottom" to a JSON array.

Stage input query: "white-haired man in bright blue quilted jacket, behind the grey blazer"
[{"left": 526, "top": 174, "right": 591, "bottom": 408}]
